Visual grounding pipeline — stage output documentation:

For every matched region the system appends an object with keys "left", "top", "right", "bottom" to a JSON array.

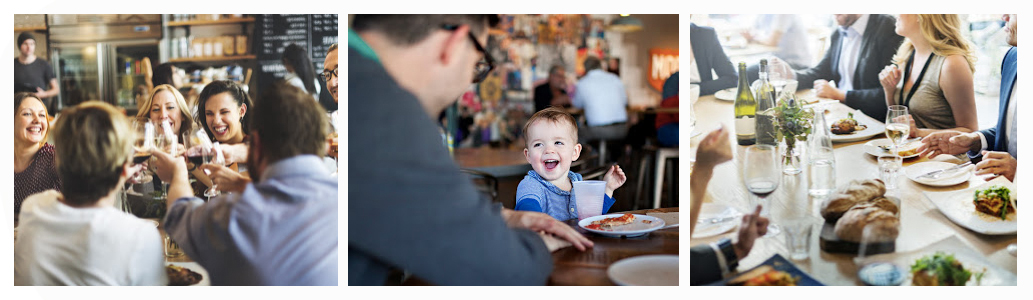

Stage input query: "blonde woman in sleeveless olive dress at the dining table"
[{"left": 879, "top": 14, "right": 978, "bottom": 137}]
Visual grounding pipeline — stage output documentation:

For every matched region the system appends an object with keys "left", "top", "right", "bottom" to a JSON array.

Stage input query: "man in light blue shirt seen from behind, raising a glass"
[{"left": 154, "top": 83, "right": 338, "bottom": 286}]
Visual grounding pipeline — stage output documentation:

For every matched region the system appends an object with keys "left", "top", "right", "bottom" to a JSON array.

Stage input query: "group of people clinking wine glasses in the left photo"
[{"left": 14, "top": 44, "right": 338, "bottom": 286}]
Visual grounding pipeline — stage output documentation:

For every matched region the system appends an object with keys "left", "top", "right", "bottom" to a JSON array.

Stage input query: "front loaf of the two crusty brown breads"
[{"left": 835, "top": 203, "right": 900, "bottom": 243}]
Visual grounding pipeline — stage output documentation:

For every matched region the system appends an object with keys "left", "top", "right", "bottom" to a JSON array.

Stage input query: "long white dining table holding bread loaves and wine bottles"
[{"left": 690, "top": 90, "right": 1018, "bottom": 286}]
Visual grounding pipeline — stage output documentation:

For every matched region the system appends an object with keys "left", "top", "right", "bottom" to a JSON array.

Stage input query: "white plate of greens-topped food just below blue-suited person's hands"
[{"left": 924, "top": 176, "right": 1019, "bottom": 235}]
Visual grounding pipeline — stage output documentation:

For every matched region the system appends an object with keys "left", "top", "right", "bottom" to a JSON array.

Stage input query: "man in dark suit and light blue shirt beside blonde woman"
[{"left": 795, "top": 14, "right": 904, "bottom": 120}]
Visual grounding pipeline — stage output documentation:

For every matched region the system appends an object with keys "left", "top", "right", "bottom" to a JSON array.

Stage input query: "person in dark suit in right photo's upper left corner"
[{"left": 689, "top": 23, "right": 739, "bottom": 95}]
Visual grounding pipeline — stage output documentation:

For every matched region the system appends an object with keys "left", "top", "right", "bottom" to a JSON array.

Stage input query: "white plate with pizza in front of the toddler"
[{"left": 577, "top": 213, "right": 664, "bottom": 238}]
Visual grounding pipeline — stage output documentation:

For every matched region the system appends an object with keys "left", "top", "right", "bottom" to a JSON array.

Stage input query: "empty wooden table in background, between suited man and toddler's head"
[{"left": 455, "top": 147, "right": 531, "bottom": 177}]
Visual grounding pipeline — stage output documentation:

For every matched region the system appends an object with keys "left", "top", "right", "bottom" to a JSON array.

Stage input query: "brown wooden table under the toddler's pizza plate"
[{"left": 549, "top": 207, "right": 679, "bottom": 286}]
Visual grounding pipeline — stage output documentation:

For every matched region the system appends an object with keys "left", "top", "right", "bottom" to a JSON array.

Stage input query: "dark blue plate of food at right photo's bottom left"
[{"left": 709, "top": 254, "right": 824, "bottom": 287}]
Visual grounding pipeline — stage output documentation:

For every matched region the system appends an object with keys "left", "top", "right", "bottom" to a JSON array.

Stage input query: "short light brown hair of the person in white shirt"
[{"left": 54, "top": 100, "right": 135, "bottom": 205}]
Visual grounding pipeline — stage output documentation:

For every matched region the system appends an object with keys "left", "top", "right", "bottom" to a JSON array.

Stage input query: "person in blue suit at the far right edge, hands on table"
[{"left": 918, "top": 14, "right": 1019, "bottom": 180}]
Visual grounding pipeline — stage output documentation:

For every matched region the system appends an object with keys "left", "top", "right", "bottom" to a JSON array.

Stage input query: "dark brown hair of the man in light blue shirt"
[{"left": 248, "top": 81, "right": 330, "bottom": 163}]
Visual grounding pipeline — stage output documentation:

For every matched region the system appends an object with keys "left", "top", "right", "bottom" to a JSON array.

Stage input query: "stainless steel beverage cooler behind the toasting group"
[{"left": 49, "top": 14, "right": 162, "bottom": 114}]
